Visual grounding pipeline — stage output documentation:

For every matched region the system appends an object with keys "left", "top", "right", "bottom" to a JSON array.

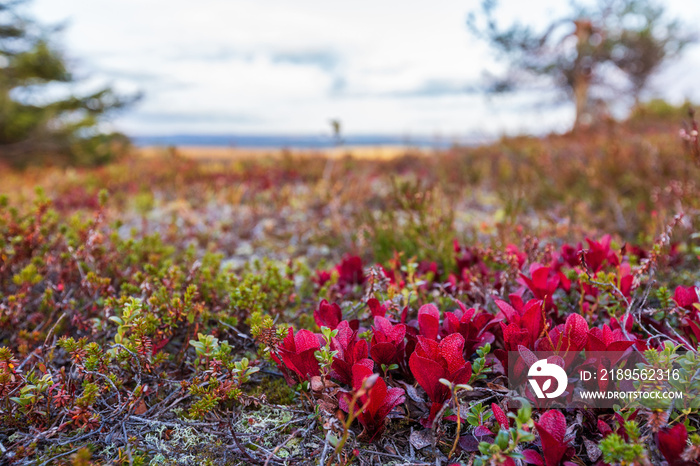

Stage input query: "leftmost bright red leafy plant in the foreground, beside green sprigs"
[{"left": 272, "top": 327, "right": 321, "bottom": 385}]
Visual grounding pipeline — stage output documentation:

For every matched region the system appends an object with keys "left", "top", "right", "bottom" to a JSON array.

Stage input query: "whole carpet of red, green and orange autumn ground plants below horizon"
[{"left": 0, "top": 118, "right": 700, "bottom": 466}]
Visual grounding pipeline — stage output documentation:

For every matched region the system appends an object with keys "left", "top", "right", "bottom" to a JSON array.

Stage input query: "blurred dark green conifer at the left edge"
[{"left": 0, "top": 0, "right": 136, "bottom": 165}]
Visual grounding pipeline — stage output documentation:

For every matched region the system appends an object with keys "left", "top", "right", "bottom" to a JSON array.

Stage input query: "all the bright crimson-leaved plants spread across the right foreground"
[{"left": 274, "top": 236, "right": 700, "bottom": 466}]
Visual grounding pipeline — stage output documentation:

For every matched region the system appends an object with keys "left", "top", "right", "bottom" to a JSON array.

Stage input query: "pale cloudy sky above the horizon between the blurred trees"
[{"left": 27, "top": 0, "right": 700, "bottom": 138}]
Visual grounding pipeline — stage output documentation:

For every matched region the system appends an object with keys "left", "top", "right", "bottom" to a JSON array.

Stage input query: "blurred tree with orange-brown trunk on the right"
[{"left": 467, "top": 0, "right": 695, "bottom": 129}]
